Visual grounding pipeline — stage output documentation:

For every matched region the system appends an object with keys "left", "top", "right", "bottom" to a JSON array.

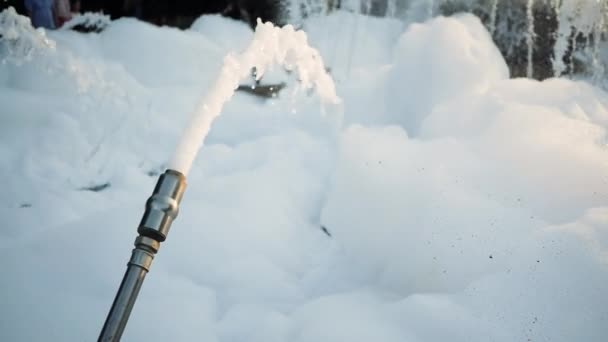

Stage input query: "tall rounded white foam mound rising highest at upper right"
[{"left": 386, "top": 14, "right": 509, "bottom": 135}]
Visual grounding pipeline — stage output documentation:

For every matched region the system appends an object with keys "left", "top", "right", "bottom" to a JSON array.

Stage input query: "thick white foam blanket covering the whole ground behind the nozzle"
[{"left": 0, "top": 9, "right": 608, "bottom": 342}]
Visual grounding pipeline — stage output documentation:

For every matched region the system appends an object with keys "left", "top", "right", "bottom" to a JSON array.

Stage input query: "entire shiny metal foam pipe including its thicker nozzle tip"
[{"left": 97, "top": 170, "right": 186, "bottom": 342}]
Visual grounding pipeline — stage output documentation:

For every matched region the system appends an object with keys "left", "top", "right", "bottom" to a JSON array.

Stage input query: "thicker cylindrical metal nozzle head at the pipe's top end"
[{"left": 137, "top": 169, "right": 186, "bottom": 242}]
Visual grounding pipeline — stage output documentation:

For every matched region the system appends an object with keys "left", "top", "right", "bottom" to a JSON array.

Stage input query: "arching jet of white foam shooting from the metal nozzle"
[{"left": 169, "top": 19, "right": 340, "bottom": 175}]
